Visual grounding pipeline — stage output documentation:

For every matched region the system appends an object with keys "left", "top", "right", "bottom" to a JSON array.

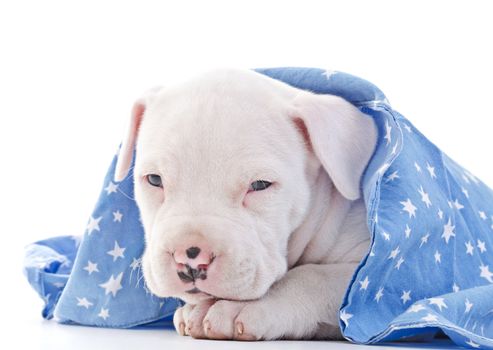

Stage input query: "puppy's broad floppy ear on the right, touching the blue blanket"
[{"left": 292, "top": 92, "right": 377, "bottom": 200}]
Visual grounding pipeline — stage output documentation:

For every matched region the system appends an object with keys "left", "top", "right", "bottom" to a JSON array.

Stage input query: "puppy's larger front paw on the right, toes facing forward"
[{"left": 203, "top": 300, "right": 275, "bottom": 340}]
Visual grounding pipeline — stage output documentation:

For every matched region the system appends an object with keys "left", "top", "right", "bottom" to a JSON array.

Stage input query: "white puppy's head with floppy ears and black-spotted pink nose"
[{"left": 116, "top": 70, "right": 376, "bottom": 302}]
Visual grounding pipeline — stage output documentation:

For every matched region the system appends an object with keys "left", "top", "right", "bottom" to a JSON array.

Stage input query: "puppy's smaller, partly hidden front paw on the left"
[{"left": 173, "top": 300, "right": 214, "bottom": 339}]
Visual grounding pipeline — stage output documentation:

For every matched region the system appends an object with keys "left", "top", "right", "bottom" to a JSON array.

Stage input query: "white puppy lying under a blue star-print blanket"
[{"left": 116, "top": 70, "right": 377, "bottom": 340}]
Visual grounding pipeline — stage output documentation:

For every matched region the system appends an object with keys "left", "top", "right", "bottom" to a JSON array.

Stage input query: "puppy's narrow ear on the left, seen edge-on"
[{"left": 114, "top": 88, "right": 160, "bottom": 181}]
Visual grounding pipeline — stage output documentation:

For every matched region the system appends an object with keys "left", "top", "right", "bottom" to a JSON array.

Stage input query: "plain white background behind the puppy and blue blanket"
[{"left": 0, "top": 0, "right": 493, "bottom": 347}]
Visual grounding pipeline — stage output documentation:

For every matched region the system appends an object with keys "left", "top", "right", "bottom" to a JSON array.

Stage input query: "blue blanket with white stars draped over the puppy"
[{"left": 24, "top": 68, "right": 493, "bottom": 348}]
